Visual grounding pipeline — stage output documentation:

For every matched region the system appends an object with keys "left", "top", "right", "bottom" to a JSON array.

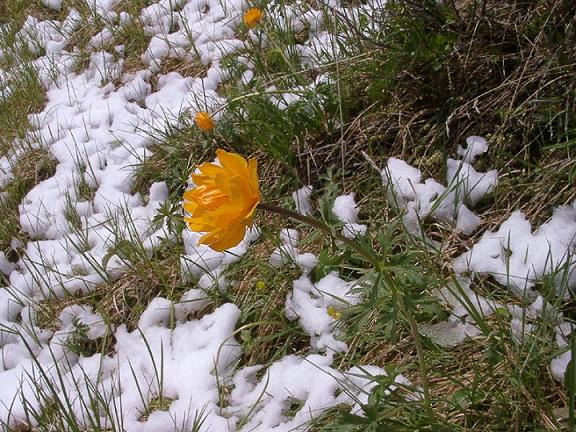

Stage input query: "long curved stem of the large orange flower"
[{"left": 258, "top": 203, "right": 435, "bottom": 417}]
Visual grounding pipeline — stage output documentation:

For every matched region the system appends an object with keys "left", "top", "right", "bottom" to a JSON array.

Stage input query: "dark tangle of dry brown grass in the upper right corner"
[{"left": 292, "top": 0, "right": 576, "bottom": 196}]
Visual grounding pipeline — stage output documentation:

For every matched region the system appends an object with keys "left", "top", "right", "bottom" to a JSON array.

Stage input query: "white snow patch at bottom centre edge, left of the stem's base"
[{"left": 227, "top": 354, "right": 410, "bottom": 432}]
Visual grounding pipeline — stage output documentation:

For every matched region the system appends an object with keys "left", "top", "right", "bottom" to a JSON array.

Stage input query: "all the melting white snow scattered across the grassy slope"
[{"left": 0, "top": 0, "right": 576, "bottom": 432}]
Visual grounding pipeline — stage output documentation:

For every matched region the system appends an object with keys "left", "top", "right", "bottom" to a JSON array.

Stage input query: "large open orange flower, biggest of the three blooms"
[{"left": 184, "top": 149, "right": 260, "bottom": 252}]
